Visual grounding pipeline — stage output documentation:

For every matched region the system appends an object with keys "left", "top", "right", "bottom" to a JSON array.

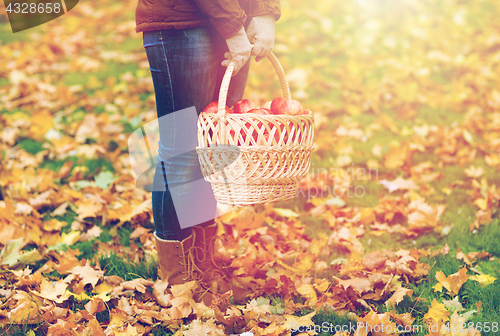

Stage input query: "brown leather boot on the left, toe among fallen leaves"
[{"left": 154, "top": 233, "right": 212, "bottom": 306}]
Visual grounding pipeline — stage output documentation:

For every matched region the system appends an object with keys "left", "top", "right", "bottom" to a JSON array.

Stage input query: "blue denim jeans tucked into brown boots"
[{"left": 143, "top": 27, "right": 250, "bottom": 240}]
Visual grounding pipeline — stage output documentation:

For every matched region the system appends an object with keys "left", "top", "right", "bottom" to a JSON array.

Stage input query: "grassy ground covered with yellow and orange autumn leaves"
[{"left": 0, "top": 0, "right": 500, "bottom": 336}]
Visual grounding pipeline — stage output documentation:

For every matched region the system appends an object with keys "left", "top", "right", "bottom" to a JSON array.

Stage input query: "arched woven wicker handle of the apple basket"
[{"left": 217, "top": 52, "right": 292, "bottom": 143}]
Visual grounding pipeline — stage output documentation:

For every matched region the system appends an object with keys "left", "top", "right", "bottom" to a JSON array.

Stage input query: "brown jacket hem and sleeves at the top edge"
[{"left": 135, "top": 0, "right": 281, "bottom": 39}]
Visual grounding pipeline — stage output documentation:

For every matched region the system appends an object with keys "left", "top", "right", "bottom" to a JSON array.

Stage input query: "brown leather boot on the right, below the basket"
[{"left": 192, "top": 223, "right": 231, "bottom": 294}]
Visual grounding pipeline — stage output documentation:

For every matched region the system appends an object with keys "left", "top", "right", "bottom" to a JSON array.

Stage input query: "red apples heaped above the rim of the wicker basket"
[{"left": 203, "top": 97, "right": 308, "bottom": 115}]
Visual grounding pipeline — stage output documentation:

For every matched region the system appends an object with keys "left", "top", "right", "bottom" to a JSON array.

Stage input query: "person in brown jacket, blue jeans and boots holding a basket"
[{"left": 136, "top": 0, "right": 280, "bottom": 300}]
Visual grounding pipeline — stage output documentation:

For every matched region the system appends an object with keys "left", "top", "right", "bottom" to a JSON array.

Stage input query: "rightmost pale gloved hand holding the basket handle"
[{"left": 247, "top": 14, "right": 275, "bottom": 62}]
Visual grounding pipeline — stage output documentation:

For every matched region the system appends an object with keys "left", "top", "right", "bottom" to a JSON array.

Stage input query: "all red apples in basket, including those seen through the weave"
[{"left": 203, "top": 97, "right": 308, "bottom": 146}]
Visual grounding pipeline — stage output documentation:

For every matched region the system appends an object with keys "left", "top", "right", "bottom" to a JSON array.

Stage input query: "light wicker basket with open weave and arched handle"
[{"left": 196, "top": 53, "right": 314, "bottom": 205}]
